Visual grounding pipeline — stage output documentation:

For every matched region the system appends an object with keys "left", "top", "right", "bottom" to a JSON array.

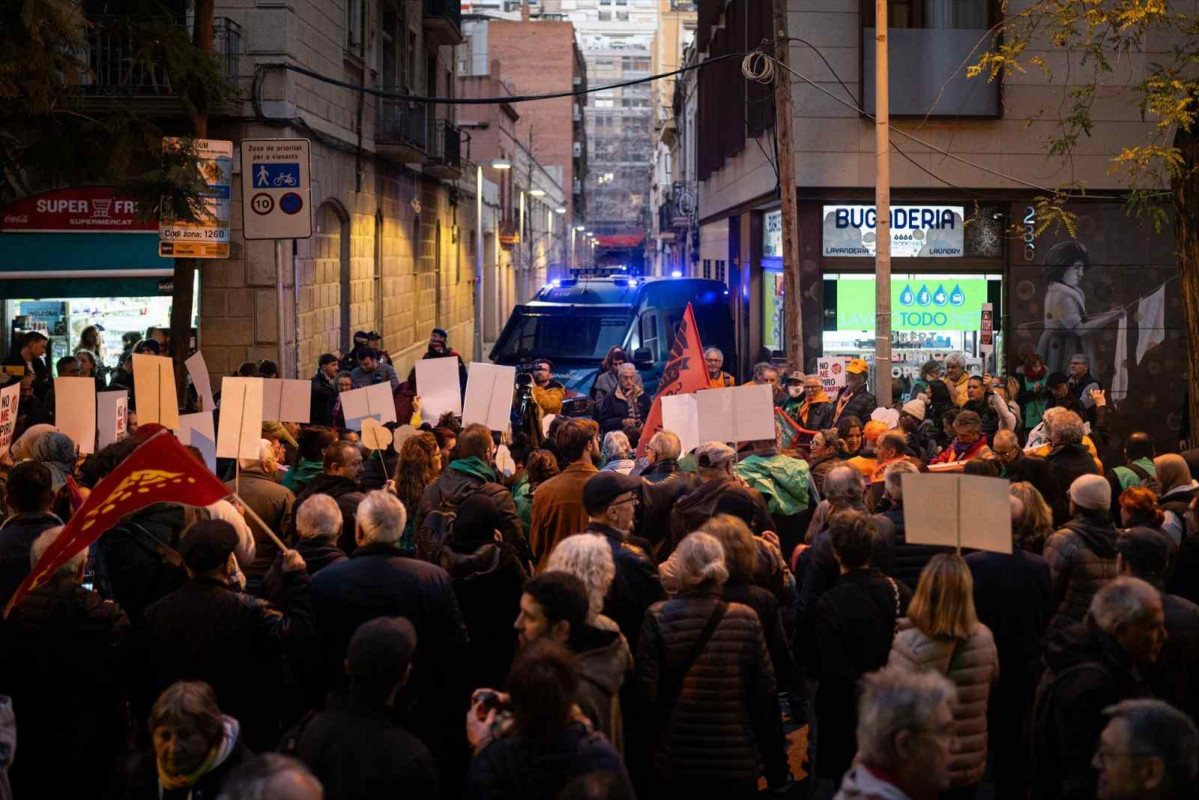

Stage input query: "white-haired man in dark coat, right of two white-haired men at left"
[{"left": 312, "top": 491, "right": 468, "bottom": 754}]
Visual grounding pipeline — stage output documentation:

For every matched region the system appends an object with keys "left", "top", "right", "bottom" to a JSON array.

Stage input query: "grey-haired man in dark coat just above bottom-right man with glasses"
[{"left": 1030, "top": 578, "right": 1165, "bottom": 800}]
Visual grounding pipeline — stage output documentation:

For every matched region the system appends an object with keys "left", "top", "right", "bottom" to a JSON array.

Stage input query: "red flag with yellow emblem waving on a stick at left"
[{"left": 4, "top": 431, "right": 229, "bottom": 618}]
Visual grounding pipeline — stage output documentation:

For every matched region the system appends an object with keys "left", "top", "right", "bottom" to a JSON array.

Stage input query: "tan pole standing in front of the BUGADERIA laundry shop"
[{"left": 874, "top": 0, "right": 891, "bottom": 408}]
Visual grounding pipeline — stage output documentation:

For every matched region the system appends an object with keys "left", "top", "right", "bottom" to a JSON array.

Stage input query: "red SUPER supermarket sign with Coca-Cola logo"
[{"left": 0, "top": 186, "right": 158, "bottom": 234}]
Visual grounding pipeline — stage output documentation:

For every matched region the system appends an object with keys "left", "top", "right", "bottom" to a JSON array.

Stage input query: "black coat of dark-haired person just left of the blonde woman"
[{"left": 802, "top": 569, "right": 911, "bottom": 778}]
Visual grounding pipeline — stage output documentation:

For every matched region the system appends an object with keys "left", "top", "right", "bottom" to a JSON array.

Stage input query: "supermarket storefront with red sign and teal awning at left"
[{"left": 0, "top": 187, "right": 199, "bottom": 367}]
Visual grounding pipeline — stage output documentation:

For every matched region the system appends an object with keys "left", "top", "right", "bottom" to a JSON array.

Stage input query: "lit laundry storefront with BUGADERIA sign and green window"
[{"left": 801, "top": 199, "right": 1007, "bottom": 393}]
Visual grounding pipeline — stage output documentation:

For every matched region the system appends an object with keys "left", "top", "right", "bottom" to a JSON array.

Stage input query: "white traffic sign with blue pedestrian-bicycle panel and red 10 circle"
[{"left": 241, "top": 139, "right": 312, "bottom": 240}]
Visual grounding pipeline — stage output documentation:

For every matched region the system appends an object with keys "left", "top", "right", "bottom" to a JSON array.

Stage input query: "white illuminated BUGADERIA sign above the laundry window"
[{"left": 823, "top": 205, "right": 965, "bottom": 258}]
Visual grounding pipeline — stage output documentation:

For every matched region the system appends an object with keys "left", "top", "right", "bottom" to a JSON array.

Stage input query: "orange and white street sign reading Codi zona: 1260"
[{"left": 158, "top": 137, "right": 233, "bottom": 258}]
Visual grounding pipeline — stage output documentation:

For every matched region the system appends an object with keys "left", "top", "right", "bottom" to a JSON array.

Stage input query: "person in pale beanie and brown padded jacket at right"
[{"left": 1044, "top": 475, "right": 1117, "bottom": 632}]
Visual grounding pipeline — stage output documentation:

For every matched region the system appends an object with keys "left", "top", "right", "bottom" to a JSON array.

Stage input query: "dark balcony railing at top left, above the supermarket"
[{"left": 80, "top": 14, "right": 241, "bottom": 115}]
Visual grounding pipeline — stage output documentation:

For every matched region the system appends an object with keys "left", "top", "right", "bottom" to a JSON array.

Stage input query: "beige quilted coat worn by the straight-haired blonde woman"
[{"left": 887, "top": 622, "right": 999, "bottom": 788}]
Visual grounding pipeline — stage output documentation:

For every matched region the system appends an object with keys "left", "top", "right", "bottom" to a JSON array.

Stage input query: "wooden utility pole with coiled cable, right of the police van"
[{"left": 775, "top": 0, "right": 805, "bottom": 372}]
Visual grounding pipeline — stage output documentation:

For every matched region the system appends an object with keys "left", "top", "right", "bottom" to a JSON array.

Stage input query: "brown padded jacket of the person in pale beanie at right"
[{"left": 1044, "top": 509, "right": 1116, "bottom": 631}]
